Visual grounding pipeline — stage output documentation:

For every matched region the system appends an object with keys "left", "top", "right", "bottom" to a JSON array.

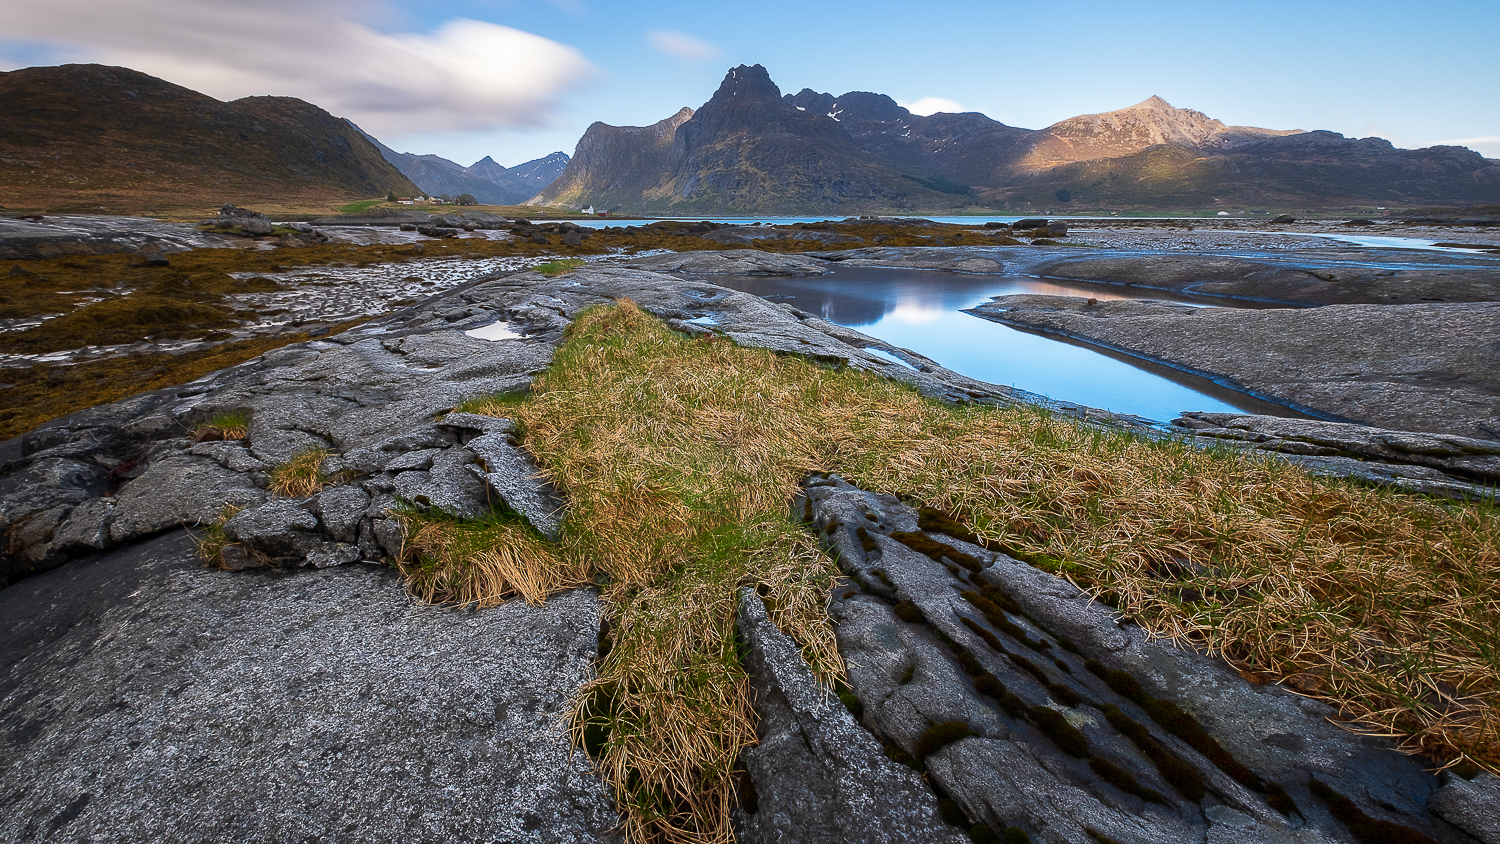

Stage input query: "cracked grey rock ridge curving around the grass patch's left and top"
[{"left": 0, "top": 263, "right": 1056, "bottom": 580}]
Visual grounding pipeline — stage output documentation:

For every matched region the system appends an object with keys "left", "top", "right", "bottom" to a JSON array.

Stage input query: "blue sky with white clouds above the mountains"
[{"left": 0, "top": 0, "right": 1500, "bottom": 166}]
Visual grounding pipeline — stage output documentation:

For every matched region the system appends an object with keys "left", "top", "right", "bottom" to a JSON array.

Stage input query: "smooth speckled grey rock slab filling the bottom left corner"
[{"left": 0, "top": 531, "right": 621, "bottom": 844}]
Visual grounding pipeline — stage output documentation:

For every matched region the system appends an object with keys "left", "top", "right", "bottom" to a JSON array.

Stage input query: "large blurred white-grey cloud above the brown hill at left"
[{"left": 5, "top": 0, "right": 596, "bottom": 136}]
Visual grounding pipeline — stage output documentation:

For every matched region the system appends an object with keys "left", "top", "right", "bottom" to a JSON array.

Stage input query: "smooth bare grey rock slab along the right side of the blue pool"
[{"left": 968, "top": 295, "right": 1500, "bottom": 439}]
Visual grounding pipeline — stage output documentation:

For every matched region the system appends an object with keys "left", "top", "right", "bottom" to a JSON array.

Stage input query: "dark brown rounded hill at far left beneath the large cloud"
[{"left": 0, "top": 64, "right": 416, "bottom": 213}]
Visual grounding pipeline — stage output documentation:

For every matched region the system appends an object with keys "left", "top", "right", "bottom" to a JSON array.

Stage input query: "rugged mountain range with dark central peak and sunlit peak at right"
[{"left": 533, "top": 64, "right": 1500, "bottom": 214}]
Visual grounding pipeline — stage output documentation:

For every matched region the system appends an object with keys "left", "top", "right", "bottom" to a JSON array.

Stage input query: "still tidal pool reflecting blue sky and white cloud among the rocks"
[{"left": 713, "top": 267, "right": 1301, "bottom": 421}]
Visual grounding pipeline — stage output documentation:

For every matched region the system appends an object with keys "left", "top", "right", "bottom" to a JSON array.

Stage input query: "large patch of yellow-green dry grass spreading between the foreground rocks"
[{"left": 408, "top": 301, "right": 1500, "bottom": 843}]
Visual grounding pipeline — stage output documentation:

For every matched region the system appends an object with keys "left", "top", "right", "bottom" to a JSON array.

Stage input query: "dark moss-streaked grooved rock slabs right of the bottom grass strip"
[{"left": 741, "top": 477, "right": 1500, "bottom": 844}]
